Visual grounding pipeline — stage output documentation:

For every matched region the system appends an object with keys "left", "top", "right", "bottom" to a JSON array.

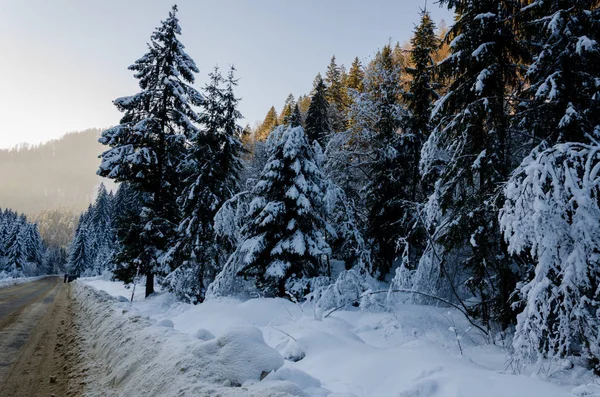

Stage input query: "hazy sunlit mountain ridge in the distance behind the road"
[{"left": 0, "top": 129, "right": 111, "bottom": 215}]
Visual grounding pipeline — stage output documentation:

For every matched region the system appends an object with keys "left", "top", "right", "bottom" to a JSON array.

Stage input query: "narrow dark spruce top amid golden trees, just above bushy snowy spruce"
[{"left": 306, "top": 74, "right": 331, "bottom": 147}]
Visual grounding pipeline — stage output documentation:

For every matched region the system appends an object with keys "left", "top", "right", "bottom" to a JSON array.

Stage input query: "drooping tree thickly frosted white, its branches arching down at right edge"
[{"left": 500, "top": 144, "right": 600, "bottom": 374}]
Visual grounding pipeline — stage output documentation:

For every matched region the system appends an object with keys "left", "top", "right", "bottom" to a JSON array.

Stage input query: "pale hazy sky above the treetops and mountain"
[{"left": 0, "top": 0, "right": 452, "bottom": 147}]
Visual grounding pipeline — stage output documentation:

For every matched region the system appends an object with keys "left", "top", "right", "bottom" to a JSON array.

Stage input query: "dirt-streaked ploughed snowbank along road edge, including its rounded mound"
[{"left": 73, "top": 282, "right": 326, "bottom": 397}]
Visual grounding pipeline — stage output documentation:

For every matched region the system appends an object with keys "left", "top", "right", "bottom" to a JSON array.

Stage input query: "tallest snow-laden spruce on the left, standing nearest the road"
[{"left": 98, "top": 6, "right": 202, "bottom": 296}]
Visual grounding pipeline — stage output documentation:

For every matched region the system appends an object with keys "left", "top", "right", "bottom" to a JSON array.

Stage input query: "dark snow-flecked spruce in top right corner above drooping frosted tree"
[{"left": 517, "top": 0, "right": 600, "bottom": 147}]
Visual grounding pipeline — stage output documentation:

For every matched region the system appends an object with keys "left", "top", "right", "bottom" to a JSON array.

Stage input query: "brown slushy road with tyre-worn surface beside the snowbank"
[{"left": 0, "top": 277, "right": 80, "bottom": 397}]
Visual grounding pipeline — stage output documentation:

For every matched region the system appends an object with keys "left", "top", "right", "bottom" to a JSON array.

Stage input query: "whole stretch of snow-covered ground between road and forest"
[{"left": 75, "top": 277, "right": 600, "bottom": 397}]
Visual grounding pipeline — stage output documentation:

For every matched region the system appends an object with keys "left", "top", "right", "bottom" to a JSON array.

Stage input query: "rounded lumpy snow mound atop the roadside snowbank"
[{"left": 192, "top": 327, "right": 283, "bottom": 385}]
